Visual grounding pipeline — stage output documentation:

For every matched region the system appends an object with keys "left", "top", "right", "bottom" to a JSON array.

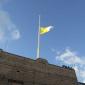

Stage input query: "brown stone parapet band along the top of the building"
[{"left": 0, "top": 50, "right": 77, "bottom": 80}]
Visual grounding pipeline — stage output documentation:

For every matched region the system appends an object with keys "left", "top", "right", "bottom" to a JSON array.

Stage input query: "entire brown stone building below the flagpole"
[{"left": 0, "top": 50, "right": 83, "bottom": 85}]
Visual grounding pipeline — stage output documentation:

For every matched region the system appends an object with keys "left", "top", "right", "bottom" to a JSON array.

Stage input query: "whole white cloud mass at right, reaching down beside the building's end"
[{"left": 56, "top": 48, "right": 85, "bottom": 83}]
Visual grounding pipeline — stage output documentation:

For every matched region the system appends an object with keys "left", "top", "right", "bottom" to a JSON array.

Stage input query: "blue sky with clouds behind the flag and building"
[{"left": 0, "top": 0, "right": 85, "bottom": 82}]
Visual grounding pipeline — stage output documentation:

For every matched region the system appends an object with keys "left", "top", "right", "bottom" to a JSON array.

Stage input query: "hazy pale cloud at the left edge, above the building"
[{"left": 0, "top": 10, "right": 20, "bottom": 42}]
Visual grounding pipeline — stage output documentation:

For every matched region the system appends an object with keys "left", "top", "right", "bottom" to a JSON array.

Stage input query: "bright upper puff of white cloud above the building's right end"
[{"left": 56, "top": 49, "right": 83, "bottom": 64}]
